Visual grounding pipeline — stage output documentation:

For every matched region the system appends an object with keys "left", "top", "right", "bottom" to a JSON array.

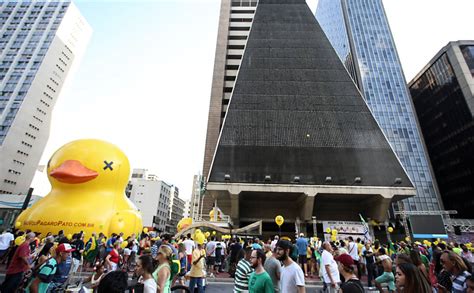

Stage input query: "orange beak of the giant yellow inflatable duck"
[{"left": 49, "top": 160, "right": 99, "bottom": 184}]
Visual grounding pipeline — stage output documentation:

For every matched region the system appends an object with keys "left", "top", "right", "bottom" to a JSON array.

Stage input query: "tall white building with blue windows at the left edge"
[{"left": 0, "top": 1, "right": 92, "bottom": 194}]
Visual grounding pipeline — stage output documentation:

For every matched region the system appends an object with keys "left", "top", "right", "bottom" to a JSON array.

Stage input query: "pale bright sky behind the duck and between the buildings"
[{"left": 33, "top": 0, "right": 474, "bottom": 198}]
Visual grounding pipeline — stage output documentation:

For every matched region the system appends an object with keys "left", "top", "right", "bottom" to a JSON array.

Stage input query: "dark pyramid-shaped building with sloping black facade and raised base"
[{"left": 207, "top": 0, "right": 415, "bottom": 228}]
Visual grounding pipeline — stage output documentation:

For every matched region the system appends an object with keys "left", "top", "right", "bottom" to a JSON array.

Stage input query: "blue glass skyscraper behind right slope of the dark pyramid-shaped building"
[{"left": 316, "top": 0, "right": 442, "bottom": 211}]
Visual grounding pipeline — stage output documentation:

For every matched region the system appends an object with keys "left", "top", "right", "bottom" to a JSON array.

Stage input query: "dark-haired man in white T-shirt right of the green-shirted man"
[{"left": 276, "top": 240, "right": 306, "bottom": 293}]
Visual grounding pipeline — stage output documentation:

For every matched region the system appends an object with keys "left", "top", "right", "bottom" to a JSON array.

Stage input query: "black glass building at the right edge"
[{"left": 409, "top": 41, "right": 474, "bottom": 219}]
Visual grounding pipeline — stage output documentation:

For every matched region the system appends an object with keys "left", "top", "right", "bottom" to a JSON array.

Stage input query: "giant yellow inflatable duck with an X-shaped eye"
[{"left": 16, "top": 139, "right": 142, "bottom": 236}]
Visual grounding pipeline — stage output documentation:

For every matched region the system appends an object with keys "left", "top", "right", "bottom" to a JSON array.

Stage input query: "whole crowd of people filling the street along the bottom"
[{"left": 0, "top": 231, "right": 474, "bottom": 293}]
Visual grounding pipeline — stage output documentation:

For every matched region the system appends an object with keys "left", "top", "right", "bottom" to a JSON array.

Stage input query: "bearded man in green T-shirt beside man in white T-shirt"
[{"left": 249, "top": 249, "right": 275, "bottom": 293}]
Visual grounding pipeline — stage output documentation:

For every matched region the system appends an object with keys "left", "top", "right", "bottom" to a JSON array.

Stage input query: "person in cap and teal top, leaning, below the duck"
[{"left": 29, "top": 243, "right": 75, "bottom": 293}]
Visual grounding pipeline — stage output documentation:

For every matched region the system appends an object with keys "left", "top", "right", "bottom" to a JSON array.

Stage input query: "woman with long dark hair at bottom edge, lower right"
[{"left": 395, "top": 263, "right": 433, "bottom": 293}]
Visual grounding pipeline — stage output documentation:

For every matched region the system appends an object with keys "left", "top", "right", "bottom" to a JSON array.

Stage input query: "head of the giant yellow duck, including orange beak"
[{"left": 48, "top": 139, "right": 130, "bottom": 192}]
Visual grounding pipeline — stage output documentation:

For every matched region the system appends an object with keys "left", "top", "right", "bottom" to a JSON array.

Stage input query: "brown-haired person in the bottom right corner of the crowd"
[{"left": 438, "top": 251, "right": 471, "bottom": 293}]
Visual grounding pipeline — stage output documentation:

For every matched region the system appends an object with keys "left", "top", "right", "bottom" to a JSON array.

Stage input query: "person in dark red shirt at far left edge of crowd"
[{"left": 0, "top": 232, "right": 35, "bottom": 292}]
